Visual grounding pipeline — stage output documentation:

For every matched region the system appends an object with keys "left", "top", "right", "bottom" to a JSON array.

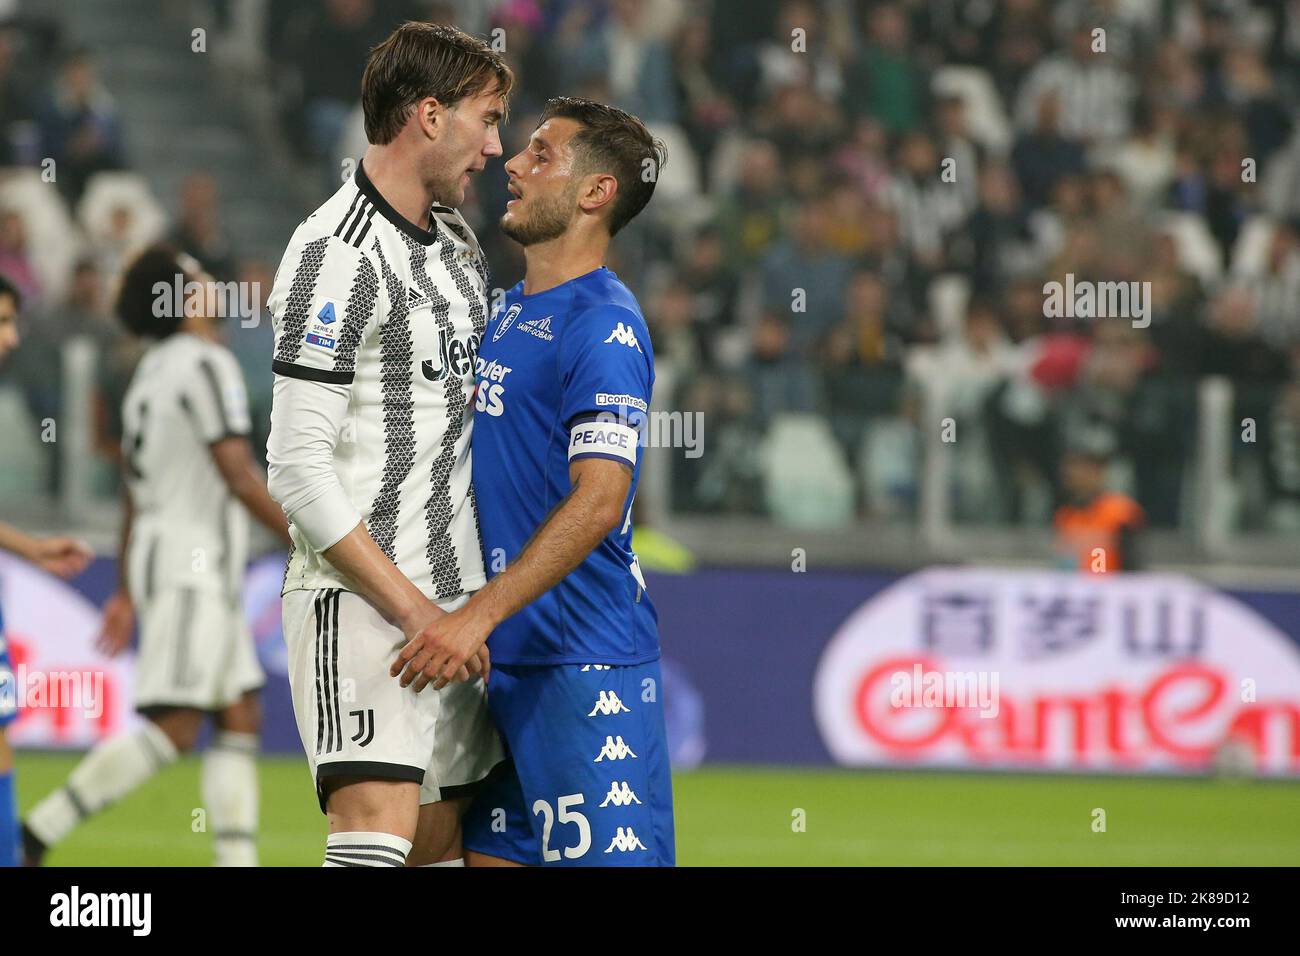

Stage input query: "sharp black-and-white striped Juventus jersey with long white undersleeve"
[{"left": 268, "top": 165, "right": 489, "bottom": 600}]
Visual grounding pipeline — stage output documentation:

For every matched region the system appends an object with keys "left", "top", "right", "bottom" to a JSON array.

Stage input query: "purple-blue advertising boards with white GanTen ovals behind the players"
[{"left": 0, "top": 555, "right": 1300, "bottom": 777}]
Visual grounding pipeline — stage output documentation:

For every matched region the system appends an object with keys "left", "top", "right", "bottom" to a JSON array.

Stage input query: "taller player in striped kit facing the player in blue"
[{"left": 267, "top": 22, "right": 514, "bottom": 866}]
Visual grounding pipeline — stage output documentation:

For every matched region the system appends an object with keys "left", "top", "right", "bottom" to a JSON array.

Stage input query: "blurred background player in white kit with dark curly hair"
[{"left": 22, "top": 246, "right": 289, "bottom": 866}]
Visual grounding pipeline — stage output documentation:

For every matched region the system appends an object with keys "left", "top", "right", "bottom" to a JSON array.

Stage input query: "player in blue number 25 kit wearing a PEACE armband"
[{"left": 394, "top": 98, "right": 676, "bottom": 866}]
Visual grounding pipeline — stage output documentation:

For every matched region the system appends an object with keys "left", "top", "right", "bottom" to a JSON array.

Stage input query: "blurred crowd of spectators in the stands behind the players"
[{"left": 0, "top": 0, "right": 1300, "bottom": 538}]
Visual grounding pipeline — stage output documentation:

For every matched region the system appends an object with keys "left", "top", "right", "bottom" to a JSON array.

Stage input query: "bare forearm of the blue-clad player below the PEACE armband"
[{"left": 471, "top": 480, "right": 621, "bottom": 627}]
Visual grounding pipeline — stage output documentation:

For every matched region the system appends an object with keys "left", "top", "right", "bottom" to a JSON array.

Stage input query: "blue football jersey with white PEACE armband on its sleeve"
[{"left": 472, "top": 267, "right": 659, "bottom": 665}]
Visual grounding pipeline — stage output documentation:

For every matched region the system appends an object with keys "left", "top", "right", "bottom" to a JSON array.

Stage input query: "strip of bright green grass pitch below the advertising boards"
[{"left": 18, "top": 752, "right": 1300, "bottom": 866}]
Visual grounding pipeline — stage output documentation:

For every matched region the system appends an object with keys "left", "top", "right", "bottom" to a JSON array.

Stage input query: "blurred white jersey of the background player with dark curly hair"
[{"left": 122, "top": 332, "right": 250, "bottom": 602}]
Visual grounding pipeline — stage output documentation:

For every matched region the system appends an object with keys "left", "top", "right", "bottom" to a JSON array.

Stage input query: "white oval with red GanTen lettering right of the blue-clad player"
[{"left": 814, "top": 568, "right": 1300, "bottom": 774}]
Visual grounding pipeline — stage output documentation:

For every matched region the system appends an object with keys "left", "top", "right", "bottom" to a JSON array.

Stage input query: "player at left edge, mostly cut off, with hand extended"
[{"left": 0, "top": 276, "right": 92, "bottom": 866}]
